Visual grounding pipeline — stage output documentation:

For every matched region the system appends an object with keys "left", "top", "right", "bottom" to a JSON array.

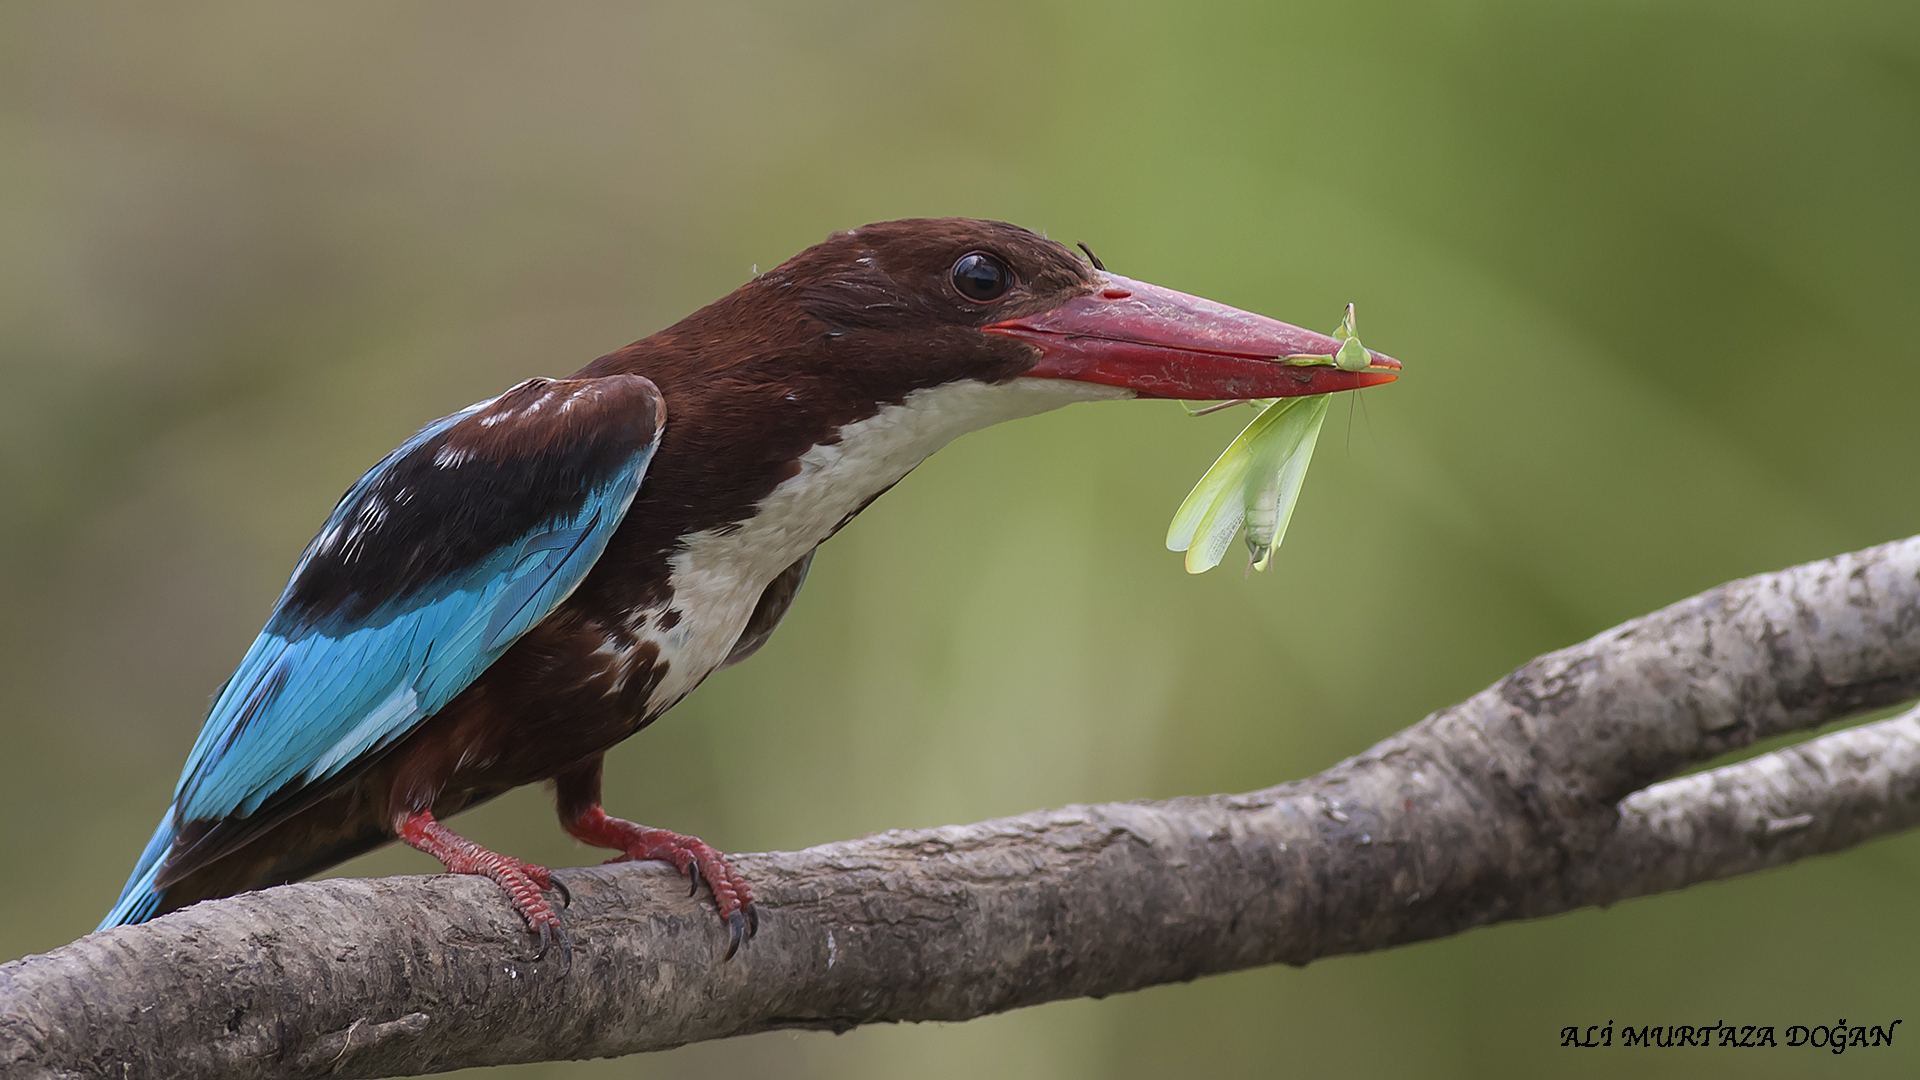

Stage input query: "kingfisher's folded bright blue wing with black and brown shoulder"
[{"left": 102, "top": 375, "right": 664, "bottom": 926}]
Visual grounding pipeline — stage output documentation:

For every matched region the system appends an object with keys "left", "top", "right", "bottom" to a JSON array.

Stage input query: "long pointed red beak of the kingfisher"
[{"left": 983, "top": 275, "right": 1400, "bottom": 402}]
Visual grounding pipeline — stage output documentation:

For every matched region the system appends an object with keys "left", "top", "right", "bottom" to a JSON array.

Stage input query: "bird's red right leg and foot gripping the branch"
[{"left": 555, "top": 757, "right": 760, "bottom": 959}]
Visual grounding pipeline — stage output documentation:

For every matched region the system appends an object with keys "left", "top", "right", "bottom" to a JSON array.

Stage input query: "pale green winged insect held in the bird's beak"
[{"left": 1167, "top": 304, "right": 1373, "bottom": 575}]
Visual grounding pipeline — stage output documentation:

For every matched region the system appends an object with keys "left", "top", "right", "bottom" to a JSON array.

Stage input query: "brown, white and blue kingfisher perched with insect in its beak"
[{"left": 100, "top": 217, "right": 1400, "bottom": 957}]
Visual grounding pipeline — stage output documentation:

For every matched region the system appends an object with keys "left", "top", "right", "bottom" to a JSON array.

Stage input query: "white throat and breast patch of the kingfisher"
[{"left": 636, "top": 379, "right": 1133, "bottom": 713}]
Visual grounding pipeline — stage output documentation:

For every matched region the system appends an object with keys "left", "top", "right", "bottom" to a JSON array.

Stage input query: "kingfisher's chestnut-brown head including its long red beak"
[{"left": 755, "top": 217, "right": 1400, "bottom": 400}]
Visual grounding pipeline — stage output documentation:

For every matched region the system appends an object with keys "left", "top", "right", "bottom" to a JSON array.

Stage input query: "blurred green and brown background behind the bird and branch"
[{"left": 0, "top": 0, "right": 1920, "bottom": 1078}]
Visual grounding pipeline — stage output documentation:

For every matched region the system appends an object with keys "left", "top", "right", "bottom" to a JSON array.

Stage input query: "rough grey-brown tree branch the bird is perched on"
[{"left": 11, "top": 538, "right": 1920, "bottom": 1080}]
